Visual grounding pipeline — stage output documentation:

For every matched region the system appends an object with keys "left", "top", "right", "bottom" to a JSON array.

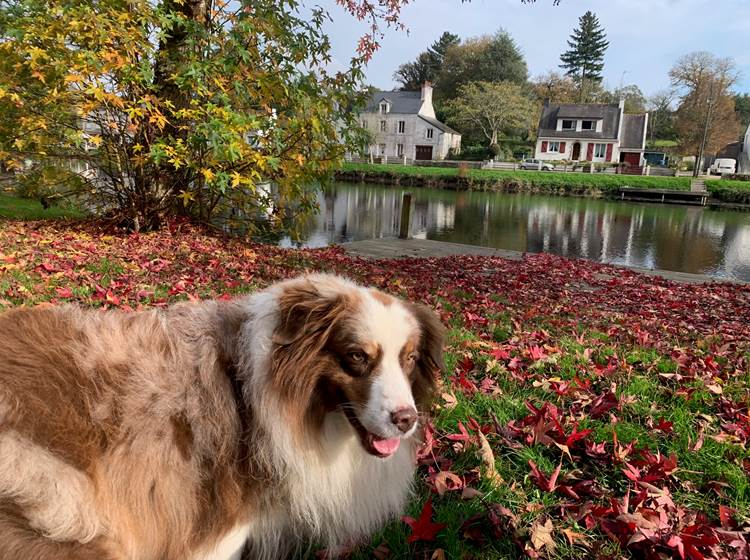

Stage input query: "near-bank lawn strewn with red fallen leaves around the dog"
[{"left": 0, "top": 218, "right": 750, "bottom": 560}]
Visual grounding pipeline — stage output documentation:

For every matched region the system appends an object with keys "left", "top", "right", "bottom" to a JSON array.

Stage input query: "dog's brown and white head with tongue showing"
[{"left": 271, "top": 275, "right": 443, "bottom": 457}]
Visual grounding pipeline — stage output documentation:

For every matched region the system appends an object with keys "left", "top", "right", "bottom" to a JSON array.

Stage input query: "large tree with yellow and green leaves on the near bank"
[{"left": 0, "top": 0, "right": 402, "bottom": 229}]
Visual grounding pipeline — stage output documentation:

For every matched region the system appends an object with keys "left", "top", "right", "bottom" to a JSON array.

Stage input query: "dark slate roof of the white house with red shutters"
[{"left": 538, "top": 103, "right": 620, "bottom": 140}]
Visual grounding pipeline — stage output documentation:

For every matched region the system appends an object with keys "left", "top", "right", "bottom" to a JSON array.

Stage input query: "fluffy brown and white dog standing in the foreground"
[{"left": 0, "top": 275, "right": 444, "bottom": 560}]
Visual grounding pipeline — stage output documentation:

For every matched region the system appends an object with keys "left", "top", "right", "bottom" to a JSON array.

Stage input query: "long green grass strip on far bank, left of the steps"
[{"left": 342, "top": 163, "right": 690, "bottom": 194}]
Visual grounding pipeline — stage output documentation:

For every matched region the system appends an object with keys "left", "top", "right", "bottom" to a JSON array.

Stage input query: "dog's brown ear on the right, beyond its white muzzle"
[{"left": 409, "top": 303, "right": 445, "bottom": 411}]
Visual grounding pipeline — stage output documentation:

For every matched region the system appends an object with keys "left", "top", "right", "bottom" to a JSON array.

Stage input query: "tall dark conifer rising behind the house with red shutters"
[{"left": 560, "top": 11, "right": 609, "bottom": 91}]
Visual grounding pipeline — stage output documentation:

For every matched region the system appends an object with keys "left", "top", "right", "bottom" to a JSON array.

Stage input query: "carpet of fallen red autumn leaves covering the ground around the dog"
[{"left": 0, "top": 222, "right": 750, "bottom": 560}]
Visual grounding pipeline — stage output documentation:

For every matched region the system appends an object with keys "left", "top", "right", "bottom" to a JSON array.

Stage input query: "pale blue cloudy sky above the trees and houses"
[{"left": 318, "top": 0, "right": 750, "bottom": 95}]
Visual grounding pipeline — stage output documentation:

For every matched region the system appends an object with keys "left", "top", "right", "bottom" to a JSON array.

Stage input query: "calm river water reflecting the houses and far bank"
[{"left": 282, "top": 184, "right": 750, "bottom": 281}]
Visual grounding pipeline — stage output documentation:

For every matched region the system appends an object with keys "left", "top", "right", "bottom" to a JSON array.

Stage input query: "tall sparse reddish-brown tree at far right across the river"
[{"left": 669, "top": 52, "right": 740, "bottom": 176}]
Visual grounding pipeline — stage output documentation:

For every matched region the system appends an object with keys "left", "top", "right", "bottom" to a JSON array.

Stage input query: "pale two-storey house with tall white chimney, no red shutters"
[{"left": 360, "top": 82, "right": 461, "bottom": 160}]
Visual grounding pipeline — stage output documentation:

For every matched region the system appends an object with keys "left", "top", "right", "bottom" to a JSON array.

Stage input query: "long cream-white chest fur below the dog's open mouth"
[{"left": 249, "top": 414, "right": 415, "bottom": 558}]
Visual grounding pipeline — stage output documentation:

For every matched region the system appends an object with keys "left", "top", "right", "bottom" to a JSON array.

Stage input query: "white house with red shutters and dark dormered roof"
[{"left": 535, "top": 100, "right": 648, "bottom": 167}]
